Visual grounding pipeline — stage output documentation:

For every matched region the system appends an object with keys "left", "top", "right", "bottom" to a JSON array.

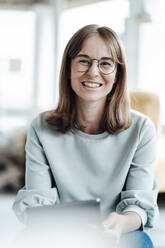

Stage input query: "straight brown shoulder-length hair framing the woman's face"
[{"left": 46, "top": 24, "right": 131, "bottom": 134}]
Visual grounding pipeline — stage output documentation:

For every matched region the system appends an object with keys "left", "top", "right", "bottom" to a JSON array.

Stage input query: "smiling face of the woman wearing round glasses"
[{"left": 71, "top": 34, "right": 116, "bottom": 102}]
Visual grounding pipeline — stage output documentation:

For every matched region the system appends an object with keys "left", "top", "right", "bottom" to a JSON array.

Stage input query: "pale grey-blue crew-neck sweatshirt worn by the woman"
[{"left": 13, "top": 110, "right": 158, "bottom": 229}]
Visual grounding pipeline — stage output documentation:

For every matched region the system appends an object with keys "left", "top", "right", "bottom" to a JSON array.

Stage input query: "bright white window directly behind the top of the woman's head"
[{"left": 59, "top": 0, "right": 129, "bottom": 68}]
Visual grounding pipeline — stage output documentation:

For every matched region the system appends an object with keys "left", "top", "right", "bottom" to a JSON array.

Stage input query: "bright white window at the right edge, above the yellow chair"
[{"left": 139, "top": 0, "right": 165, "bottom": 126}]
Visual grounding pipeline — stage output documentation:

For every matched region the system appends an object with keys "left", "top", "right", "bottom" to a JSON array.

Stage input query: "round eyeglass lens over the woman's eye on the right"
[{"left": 99, "top": 59, "right": 115, "bottom": 74}]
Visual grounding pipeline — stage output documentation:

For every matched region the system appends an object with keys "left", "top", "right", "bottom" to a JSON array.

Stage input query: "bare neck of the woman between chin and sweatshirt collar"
[{"left": 77, "top": 101, "right": 105, "bottom": 134}]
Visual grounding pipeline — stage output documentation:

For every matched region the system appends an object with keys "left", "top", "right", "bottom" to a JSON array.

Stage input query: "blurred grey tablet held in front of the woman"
[{"left": 27, "top": 199, "right": 101, "bottom": 228}]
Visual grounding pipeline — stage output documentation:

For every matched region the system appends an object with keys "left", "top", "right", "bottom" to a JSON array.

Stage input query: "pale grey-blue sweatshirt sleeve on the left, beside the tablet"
[{"left": 13, "top": 115, "right": 59, "bottom": 224}]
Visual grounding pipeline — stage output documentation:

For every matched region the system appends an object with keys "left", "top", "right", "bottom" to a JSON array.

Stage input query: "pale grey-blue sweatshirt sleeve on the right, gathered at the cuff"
[{"left": 116, "top": 118, "right": 159, "bottom": 229}]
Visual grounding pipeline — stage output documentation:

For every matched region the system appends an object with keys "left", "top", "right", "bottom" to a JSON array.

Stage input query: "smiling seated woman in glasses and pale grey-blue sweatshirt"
[{"left": 13, "top": 25, "right": 158, "bottom": 247}]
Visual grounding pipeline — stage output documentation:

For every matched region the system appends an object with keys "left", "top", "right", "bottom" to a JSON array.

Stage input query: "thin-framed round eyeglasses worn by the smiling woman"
[{"left": 74, "top": 55, "right": 116, "bottom": 75}]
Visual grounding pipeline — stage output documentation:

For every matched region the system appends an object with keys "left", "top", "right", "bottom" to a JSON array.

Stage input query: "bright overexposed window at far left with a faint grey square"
[{"left": 0, "top": 10, "right": 35, "bottom": 128}]
